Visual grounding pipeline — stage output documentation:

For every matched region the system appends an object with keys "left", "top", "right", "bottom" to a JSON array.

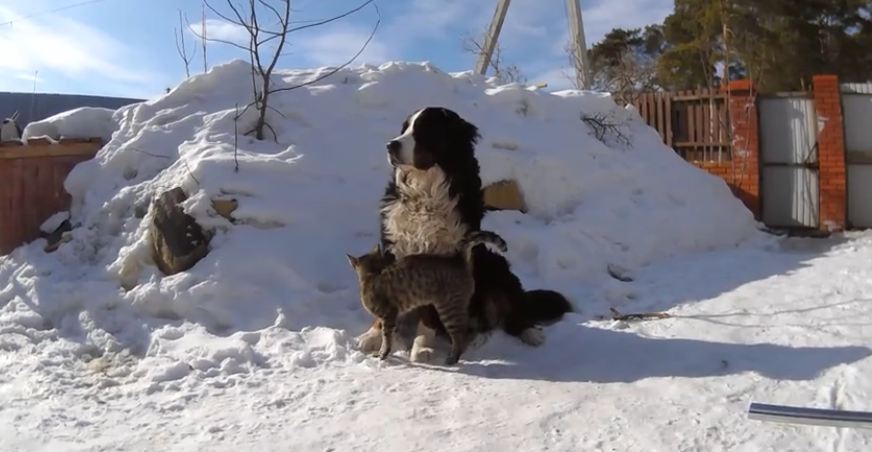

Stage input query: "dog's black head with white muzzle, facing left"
[{"left": 387, "top": 107, "right": 479, "bottom": 170}]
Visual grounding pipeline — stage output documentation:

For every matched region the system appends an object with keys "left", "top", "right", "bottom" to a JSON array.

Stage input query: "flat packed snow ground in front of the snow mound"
[{"left": 0, "top": 234, "right": 872, "bottom": 451}]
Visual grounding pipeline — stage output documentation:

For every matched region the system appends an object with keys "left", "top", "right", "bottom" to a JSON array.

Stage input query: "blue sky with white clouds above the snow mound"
[{"left": 0, "top": 0, "right": 673, "bottom": 98}]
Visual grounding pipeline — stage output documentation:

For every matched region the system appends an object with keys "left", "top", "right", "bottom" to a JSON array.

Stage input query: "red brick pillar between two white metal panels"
[{"left": 812, "top": 75, "right": 848, "bottom": 231}]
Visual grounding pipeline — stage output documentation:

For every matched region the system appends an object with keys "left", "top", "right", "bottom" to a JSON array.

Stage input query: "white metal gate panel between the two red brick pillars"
[{"left": 758, "top": 93, "right": 820, "bottom": 228}]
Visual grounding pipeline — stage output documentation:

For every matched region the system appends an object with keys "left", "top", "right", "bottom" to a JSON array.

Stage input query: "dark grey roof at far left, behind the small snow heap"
[{"left": 0, "top": 92, "right": 142, "bottom": 129}]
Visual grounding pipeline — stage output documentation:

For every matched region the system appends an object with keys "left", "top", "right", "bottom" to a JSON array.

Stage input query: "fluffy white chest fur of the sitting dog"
[{"left": 383, "top": 171, "right": 467, "bottom": 257}]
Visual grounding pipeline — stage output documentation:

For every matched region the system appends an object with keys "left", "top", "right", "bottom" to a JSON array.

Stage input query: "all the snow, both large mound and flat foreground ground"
[{"left": 0, "top": 61, "right": 872, "bottom": 451}]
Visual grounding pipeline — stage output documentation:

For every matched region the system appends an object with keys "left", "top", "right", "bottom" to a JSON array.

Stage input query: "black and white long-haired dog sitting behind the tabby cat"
[{"left": 358, "top": 107, "right": 572, "bottom": 362}]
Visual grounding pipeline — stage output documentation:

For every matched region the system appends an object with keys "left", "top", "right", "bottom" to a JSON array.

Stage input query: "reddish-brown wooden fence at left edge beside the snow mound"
[{"left": 0, "top": 139, "right": 102, "bottom": 255}]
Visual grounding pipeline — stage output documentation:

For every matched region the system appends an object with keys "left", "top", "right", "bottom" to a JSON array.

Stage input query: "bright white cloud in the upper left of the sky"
[{"left": 0, "top": 6, "right": 164, "bottom": 92}]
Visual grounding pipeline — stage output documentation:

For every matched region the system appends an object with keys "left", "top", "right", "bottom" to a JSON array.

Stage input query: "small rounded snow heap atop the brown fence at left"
[{"left": 24, "top": 107, "right": 118, "bottom": 141}]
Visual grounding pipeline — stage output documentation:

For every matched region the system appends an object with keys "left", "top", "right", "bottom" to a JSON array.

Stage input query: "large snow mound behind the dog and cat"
[{"left": 0, "top": 61, "right": 755, "bottom": 385}]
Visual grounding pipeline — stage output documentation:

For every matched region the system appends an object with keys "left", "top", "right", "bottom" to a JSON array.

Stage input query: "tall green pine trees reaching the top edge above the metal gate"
[{"left": 657, "top": 0, "right": 872, "bottom": 91}]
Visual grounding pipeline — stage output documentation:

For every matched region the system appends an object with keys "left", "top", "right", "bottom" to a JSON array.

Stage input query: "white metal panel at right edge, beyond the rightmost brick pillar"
[{"left": 842, "top": 84, "right": 872, "bottom": 228}]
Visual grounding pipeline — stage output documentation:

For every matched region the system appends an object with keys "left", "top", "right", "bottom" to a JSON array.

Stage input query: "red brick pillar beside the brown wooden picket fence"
[{"left": 721, "top": 80, "right": 760, "bottom": 220}]
